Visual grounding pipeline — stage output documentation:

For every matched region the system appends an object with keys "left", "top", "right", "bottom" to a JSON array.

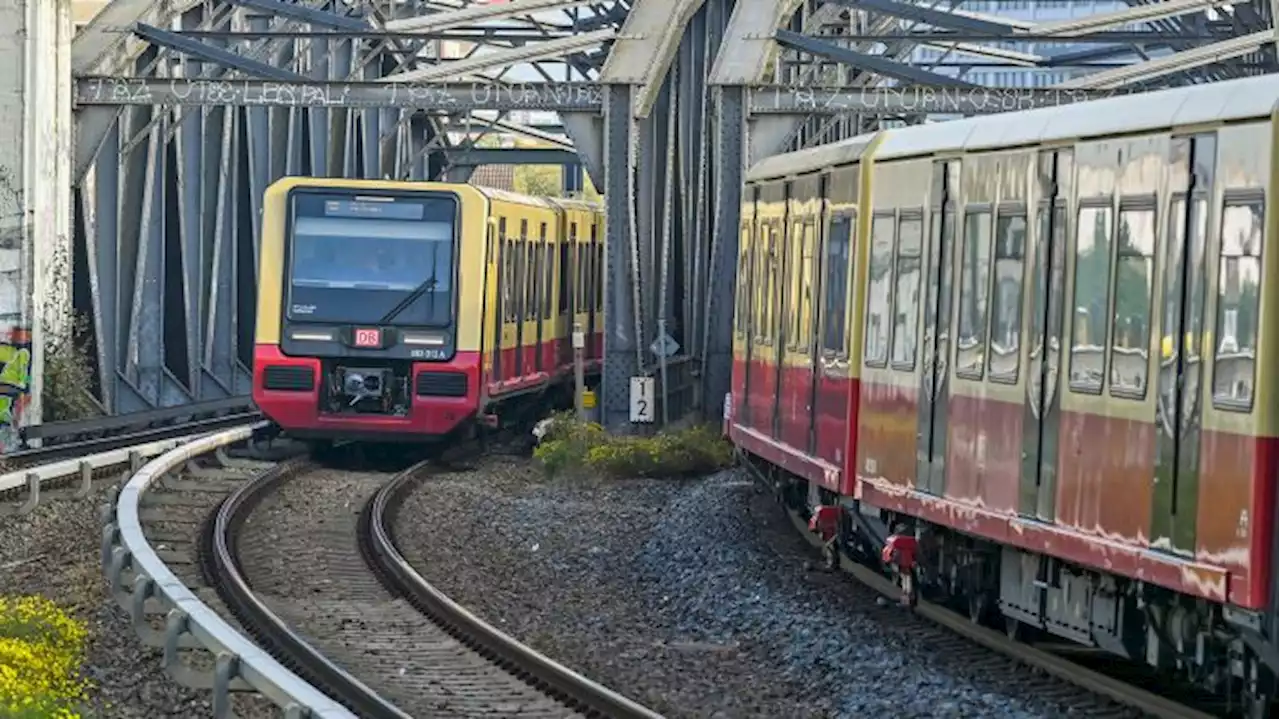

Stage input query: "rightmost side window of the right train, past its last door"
[{"left": 1213, "top": 191, "right": 1265, "bottom": 412}]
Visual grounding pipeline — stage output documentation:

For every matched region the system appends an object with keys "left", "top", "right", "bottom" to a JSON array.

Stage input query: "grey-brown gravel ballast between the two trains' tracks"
[{"left": 394, "top": 457, "right": 1121, "bottom": 719}]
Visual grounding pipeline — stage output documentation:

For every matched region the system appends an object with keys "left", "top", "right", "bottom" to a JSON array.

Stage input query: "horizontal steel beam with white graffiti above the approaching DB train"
[{"left": 74, "top": 77, "right": 603, "bottom": 113}]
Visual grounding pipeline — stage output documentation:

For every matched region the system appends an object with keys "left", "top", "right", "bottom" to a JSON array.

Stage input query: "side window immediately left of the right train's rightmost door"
[{"left": 1108, "top": 205, "right": 1156, "bottom": 398}]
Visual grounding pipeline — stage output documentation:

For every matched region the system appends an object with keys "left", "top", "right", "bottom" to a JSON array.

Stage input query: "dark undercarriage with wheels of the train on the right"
[{"left": 745, "top": 455, "right": 1280, "bottom": 719}]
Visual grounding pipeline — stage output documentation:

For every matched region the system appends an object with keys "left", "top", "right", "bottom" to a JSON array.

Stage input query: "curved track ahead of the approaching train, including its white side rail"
[{"left": 102, "top": 429, "right": 658, "bottom": 719}]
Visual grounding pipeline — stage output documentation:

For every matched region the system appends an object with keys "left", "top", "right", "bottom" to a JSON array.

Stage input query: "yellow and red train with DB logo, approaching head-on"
[{"left": 253, "top": 178, "right": 604, "bottom": 443}]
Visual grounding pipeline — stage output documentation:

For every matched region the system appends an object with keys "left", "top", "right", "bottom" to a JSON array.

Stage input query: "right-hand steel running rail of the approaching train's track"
[{"left": 361, "top": 464, "right": 662, "bottom": 719}]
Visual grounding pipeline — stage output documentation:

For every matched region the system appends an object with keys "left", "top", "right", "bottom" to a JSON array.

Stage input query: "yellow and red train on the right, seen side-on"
[{"left": 726, "top": 75, "right": 1280, "bottom": 715}]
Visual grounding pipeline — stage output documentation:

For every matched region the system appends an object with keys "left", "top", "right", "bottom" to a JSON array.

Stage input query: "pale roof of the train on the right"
[{"left": 746, "top": 74, "right": 1280, "bottom": 180}]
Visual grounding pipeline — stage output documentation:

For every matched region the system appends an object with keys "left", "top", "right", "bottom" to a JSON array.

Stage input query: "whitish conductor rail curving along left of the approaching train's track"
[{"left": 102, "top": 422, "right": 355, "bottom": 719}]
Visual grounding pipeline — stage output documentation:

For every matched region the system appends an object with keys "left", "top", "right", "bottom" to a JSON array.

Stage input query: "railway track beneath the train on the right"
[{"left": 753, "top": 458, "right": 1215, "bottom": 719}]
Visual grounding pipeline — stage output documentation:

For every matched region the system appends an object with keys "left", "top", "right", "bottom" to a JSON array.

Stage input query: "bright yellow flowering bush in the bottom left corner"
[{"left": 0, "top": 596, "right": 88, "bottom": 719}]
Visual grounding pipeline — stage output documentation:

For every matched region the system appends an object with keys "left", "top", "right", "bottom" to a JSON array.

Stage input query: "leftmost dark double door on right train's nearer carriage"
[{"left": 915, "top": 161, "right": 960, "bottom": 495}]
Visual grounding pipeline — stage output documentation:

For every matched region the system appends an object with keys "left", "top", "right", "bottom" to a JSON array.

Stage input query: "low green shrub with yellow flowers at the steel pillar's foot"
[{"left": 534, "top": 412, "right": 733, "bottom": 477}]
